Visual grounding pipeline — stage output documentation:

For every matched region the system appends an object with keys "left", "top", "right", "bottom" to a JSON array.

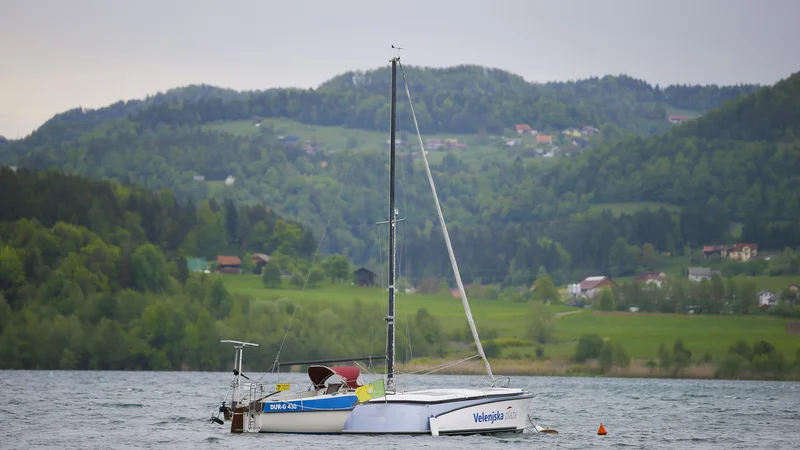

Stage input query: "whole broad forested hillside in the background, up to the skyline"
[{"left": 0, "top": 66, "right": 800, "bottom": 286}]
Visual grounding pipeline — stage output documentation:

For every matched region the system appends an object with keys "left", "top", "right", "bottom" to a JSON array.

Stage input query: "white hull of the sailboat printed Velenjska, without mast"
[{"left": 342, "top": 388, "right": 533, "bottom": 435}]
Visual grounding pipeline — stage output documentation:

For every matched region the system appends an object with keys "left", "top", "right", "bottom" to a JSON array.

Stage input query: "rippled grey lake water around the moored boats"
[{"left": 0, "top": 371, "right": 800, "bottom": 450}]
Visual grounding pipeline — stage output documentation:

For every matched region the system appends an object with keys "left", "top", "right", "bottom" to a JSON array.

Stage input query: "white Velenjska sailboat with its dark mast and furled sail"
[{"left": 342, "top": 55, "right": 533, "bottom": 436}]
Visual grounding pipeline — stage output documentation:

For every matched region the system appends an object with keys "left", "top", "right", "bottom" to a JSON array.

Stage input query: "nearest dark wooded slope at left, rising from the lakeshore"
[{"left": 0, "top": 166, "right": 412, "bottom": 371}]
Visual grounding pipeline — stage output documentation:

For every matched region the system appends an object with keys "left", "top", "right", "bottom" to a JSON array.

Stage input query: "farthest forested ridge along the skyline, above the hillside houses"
[{"left": 3, "top": 66, "right": 757, "bottom": 149}]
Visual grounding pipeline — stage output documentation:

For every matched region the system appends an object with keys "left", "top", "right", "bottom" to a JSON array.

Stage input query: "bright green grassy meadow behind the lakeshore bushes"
[{"left": 223, "top": 275, "right": 800, "bottom": 360}]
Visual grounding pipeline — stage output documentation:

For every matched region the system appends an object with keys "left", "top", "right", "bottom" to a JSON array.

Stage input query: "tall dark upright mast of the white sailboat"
[{"left": 386, "top": 56, "right": 400, "bottom": 392}]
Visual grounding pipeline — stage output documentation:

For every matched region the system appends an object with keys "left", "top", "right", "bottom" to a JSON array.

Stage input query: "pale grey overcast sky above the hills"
[{"left": 0, "top": 0, "right": 800, "bottom": 138}]
